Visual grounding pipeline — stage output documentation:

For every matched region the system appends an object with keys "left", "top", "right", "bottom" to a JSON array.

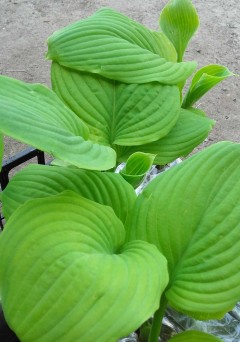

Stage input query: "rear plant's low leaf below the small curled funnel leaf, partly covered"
[{"left": 118, "top": 109, "right": 215, "bottom": 165}]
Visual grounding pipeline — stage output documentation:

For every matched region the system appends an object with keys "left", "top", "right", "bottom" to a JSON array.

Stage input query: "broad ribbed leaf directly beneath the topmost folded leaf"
[{"left": 52, "top": 63, "right": 180, "bottom": 146}]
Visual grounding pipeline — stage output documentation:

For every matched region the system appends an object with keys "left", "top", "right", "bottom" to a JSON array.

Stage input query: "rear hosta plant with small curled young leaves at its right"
[{"left": 0, "top": 0, "right": 232, "bottom": 170}]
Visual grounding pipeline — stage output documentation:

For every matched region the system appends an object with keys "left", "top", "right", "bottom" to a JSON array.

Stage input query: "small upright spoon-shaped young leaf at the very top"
[{"left": 160, "top": 0, "right": 199, "bottom": 62}]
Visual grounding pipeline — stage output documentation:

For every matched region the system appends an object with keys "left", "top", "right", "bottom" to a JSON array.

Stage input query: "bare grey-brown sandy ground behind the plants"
[{"left": 0, "top": 0, "right": 240, "bottom": 158}]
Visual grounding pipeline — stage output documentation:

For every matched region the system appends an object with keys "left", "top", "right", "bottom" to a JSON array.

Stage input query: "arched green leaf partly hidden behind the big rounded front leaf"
[{"left": 2, "top": 164, "right": 136, "bottom": 223}]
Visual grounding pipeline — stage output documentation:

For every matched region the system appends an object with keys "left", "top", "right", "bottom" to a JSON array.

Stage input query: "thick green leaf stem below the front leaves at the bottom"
[{"left": 148, "top": 293, "right": 168, "bottom": 342}]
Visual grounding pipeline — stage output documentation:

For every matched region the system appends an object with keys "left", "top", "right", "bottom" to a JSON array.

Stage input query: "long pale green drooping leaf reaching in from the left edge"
[{"left": 0, "top": 76, "right": 116, "bottom": 170}]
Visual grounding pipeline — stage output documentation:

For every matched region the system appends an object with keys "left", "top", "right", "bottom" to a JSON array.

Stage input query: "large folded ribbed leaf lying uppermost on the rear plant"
[{"left": 46, "top": 8, "right": 196, "bottom": 84}]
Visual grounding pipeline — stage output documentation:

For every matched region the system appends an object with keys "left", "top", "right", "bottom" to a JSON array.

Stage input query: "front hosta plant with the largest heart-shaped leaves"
[{"left": 0, "top": 142, "right": 240, "bottom": 342}]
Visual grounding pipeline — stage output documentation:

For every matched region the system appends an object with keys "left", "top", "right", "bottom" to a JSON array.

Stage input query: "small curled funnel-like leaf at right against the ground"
[{"left": 182, "top": 64, "right": 234, "bottom": 108}]
